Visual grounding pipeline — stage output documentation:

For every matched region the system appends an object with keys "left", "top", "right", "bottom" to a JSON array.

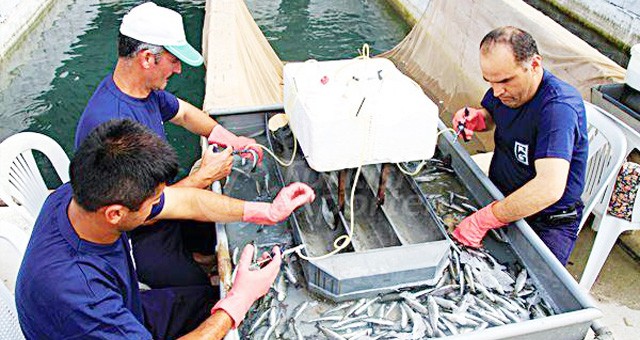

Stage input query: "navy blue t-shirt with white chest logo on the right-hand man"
[{"left": 482, "top": 70, "right": 589, "bottom": 213}]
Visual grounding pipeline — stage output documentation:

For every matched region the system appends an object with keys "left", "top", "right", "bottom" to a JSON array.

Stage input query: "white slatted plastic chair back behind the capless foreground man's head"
[{"left": 0, "top": 132, "right": 69, "bottom": 225}]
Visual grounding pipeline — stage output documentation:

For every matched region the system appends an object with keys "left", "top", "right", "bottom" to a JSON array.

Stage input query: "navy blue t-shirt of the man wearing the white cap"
[{"left": 75, "top": 74, "right": 179, "bottom": 149}]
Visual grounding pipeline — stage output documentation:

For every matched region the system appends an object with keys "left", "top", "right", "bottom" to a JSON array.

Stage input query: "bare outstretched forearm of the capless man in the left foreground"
[{"left": 152, "top": 186, "right": 244, "bottom": 222}]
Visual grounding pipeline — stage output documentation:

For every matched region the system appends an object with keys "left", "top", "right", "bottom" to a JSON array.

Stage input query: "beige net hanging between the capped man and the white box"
[{"left": 202, "top": 0, "right": 282, "bottom": 113}]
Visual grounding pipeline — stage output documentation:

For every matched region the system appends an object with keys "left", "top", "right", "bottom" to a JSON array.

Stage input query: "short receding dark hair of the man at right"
[{"left": 480, "top": 26, "right": 540, "bottom": 62}]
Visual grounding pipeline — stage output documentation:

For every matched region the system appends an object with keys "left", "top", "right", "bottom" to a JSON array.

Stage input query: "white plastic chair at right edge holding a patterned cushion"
[{"left": 580, "top": 123, "right": 640, "bottom": 290}]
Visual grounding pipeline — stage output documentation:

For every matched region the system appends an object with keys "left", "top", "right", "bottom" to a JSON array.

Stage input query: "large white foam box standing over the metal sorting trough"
[{"left": 284, "top": 58, "right": 438, "bottom": 171}]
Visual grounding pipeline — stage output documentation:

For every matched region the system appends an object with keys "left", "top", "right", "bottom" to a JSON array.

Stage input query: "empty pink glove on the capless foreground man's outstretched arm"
[{"left": 242, "top": 182, "right": 316, "bottom": 225}]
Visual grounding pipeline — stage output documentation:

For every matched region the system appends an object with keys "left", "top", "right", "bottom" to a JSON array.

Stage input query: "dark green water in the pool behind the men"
[{"left": 0, "top": 0, "right": 409, "bottom": 179}]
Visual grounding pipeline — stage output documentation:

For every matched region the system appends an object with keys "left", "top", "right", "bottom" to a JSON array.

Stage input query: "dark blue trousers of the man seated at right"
[{"left": 529, "top": 206, "right": 582, "bottom": 266}]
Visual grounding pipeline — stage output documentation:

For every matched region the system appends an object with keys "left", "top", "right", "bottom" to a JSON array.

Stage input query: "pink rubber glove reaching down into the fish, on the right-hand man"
[{"left": 453, "top": 201, "right": 507, "bottom": 248}]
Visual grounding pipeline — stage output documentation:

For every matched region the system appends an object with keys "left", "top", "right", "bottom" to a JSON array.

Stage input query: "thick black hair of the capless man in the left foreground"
[{"left": 70, "top": 120, "right": 178, "bottom": 211}]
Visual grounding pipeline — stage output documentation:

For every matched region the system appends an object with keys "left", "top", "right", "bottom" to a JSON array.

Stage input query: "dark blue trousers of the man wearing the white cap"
[{"left": 129, "top": 220, "right": 216, "bottom": 289}]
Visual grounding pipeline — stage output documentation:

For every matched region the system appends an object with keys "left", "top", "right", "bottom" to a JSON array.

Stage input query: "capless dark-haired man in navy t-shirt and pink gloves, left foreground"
[{"left": 16, "top": 120, "right": 314, "bottom": 339}]
